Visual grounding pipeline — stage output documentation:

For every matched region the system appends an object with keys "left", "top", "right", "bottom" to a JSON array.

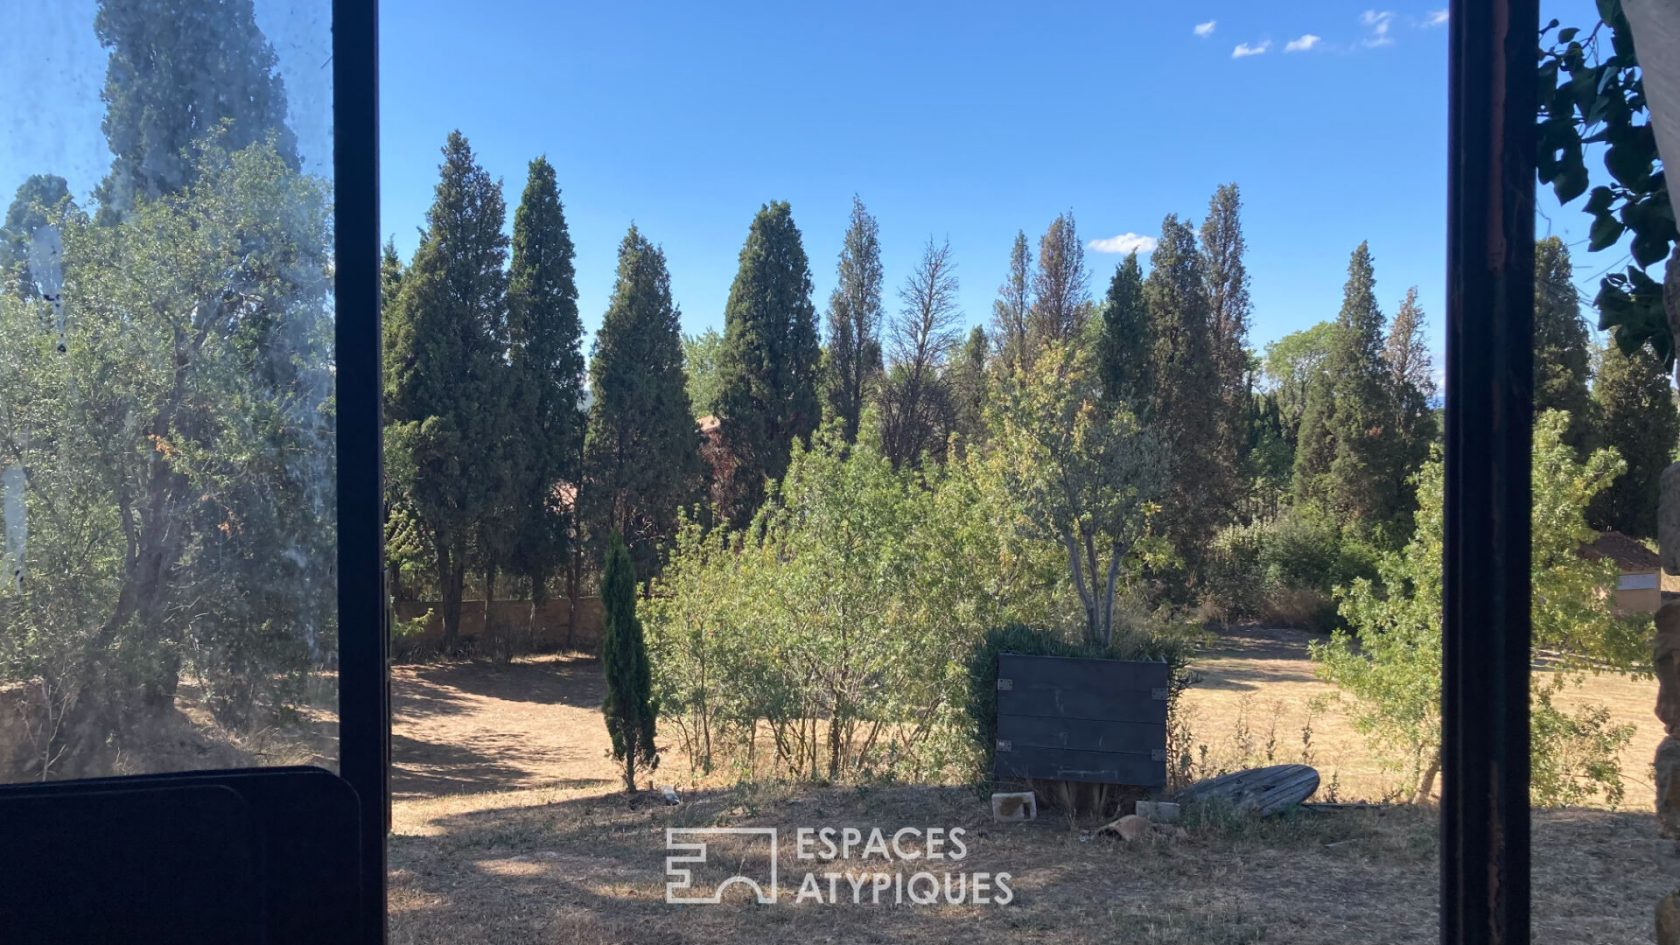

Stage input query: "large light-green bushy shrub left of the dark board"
[{"left": 648, "top": 423, "right": 1057, "bottom": 779}]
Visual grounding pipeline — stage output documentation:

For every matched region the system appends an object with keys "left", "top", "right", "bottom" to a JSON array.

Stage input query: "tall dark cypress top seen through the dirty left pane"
[{"left": 94, "top": 0, "right": 299, "bottom": 219}]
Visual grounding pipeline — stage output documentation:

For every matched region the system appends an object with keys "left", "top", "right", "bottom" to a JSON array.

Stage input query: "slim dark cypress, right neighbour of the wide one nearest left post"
[{"left": 507, "top": 158, "right": 585, "bottom": 604}]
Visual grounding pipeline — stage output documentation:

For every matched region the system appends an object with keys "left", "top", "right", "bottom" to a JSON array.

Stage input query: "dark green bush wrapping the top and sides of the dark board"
[{"left": 963, "top": 624, "right": 1189, "bottom": 784}]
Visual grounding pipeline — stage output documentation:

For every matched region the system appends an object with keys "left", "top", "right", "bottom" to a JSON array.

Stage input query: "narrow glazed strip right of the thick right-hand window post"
[{"left": 1530, "top": 0, "right": 1680, "bottom": 942}]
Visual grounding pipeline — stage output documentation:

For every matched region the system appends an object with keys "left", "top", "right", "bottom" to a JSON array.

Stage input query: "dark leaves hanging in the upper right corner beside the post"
[{"left": 1536, "top": 7, "right": 1675, "bottom": 359}]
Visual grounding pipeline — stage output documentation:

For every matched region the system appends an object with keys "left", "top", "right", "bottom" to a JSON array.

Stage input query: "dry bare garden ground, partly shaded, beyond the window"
[{"left": 390, "top": 632, "right": 1680, "bottom": 945}]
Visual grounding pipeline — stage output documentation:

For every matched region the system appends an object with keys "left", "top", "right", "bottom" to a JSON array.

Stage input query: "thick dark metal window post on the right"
[{"left": 1441, "top": 0, "right": 1539, "bottom": 945}]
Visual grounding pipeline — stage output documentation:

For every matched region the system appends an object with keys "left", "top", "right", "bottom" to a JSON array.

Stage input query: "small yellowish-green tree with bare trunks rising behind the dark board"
[{"left": 988, "top": 345, "right": 1168, "bottom": 647}]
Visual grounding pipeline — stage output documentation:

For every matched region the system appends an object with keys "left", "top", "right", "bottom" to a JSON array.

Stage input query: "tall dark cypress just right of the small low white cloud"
[{"left": 1144, "top": 215, "right": 1236, "bottom": 575}]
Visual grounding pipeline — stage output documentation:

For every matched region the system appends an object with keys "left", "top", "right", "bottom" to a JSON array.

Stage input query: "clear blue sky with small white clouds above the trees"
[{"left": 0, "top": 0, "right": 1614, "bottom": 373}]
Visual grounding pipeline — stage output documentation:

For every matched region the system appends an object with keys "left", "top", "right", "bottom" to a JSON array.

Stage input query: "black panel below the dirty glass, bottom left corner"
[{"left": 0, "top": 768, "right": 366, "bottom": 945}]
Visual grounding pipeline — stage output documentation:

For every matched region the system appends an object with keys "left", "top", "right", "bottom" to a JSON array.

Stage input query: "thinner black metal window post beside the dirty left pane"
[{"left": 333, "top": 0, "right": 390, "bottom": 945}]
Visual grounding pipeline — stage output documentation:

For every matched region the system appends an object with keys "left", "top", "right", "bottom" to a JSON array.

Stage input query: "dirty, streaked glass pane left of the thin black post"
[{"left": 0, "top": 0, "right": 338, "bottom": 782}]
